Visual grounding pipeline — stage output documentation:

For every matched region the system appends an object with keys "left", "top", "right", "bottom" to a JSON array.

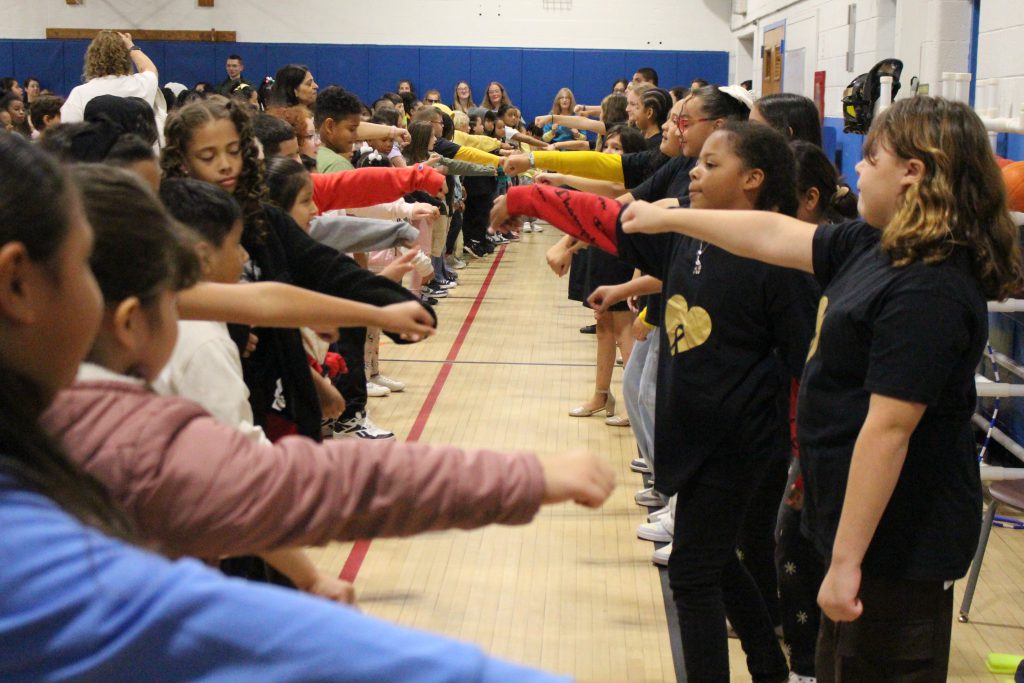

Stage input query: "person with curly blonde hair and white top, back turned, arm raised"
[{"left": 60, "top": 31, "right": 167, "bottom": 144}]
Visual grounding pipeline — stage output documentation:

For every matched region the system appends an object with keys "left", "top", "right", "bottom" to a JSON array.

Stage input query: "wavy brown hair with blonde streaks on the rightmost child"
[{"left": 864, "top": 97, "right": 1022, "bottom": 299}]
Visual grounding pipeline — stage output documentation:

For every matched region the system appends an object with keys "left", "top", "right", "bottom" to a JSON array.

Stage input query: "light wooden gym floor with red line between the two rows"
[{"left": 310, "top": 227, "right": 1024, "bottom": 683}]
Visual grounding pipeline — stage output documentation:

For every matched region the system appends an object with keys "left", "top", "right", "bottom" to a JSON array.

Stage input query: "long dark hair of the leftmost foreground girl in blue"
[{"left": 0, "top": 135, "right": 132, "bottom": 540}]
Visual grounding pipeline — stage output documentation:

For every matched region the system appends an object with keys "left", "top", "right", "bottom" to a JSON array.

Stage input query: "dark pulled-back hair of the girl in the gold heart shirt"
[{"left": 718, "top": 121, "right": 797, "bottom": 216}]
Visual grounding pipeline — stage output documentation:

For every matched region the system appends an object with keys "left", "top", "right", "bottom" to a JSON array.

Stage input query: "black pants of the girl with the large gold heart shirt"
[{"left": 669, "top": 454, "right": 788, "bottom": 683}]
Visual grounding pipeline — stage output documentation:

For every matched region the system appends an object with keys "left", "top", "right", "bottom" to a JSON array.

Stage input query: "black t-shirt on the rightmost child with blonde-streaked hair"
[{"left": 797, "top": 221, "right": 988, "bottom": 581}]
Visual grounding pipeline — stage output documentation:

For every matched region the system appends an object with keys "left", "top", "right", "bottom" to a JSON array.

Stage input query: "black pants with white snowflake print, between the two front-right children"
[{"left": 775, "top": 504, "right": 825, "bottom": 678}]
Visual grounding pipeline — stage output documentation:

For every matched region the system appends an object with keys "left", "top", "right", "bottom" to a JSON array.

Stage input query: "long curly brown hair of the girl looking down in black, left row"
[{"left": 160, "top": 95, "right": 266, "bottom": 238}]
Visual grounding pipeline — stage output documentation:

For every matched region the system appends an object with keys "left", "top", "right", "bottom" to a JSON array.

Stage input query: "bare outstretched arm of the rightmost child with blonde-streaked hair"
[{"left": 623, "top": 202, "right": 816, "bottom": 272}]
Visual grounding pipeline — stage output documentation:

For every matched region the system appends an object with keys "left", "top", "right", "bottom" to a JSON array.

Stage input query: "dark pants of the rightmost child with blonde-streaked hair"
[{"left": 817, "top": 575, "right": 953, "bottom": 683}]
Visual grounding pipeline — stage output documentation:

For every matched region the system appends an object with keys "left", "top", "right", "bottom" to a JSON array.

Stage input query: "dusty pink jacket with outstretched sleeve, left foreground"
[{"left": 43, "top": 381, "right": 544, "bottom": 557}]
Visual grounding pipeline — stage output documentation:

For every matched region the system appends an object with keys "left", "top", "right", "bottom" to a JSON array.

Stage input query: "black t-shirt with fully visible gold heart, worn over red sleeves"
[{"left": 617, "top": 218, "right": 816, "bottom": 494}]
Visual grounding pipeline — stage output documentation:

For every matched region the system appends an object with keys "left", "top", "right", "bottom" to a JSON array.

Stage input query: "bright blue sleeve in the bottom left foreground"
[{"left": 0, "top": 474, "right": 567, "bottom": 683}]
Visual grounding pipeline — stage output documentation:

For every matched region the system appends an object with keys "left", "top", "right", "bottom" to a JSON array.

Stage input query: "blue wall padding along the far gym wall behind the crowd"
[{"left": 0, "top": 40, "right": 729, "bottom": 117}]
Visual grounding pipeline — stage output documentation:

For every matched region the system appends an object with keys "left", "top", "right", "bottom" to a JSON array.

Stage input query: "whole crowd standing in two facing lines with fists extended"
[{"left": 0, "top": 31, "right": 1021, "bottom": 683}]
